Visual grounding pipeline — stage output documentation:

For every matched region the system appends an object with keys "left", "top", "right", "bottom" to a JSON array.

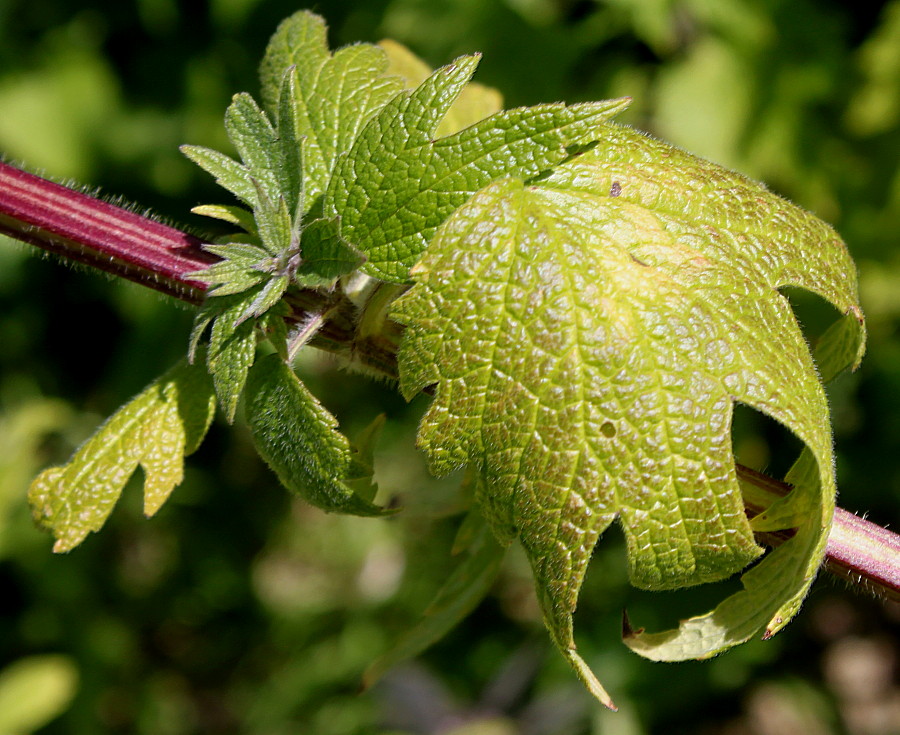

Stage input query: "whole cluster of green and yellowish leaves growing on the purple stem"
[{"left": 32, "top": 4, "right": 864, "bottom": 706}]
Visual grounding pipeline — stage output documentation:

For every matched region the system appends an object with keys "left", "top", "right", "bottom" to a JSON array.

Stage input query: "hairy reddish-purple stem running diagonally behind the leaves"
[{"left": 0, "top": 162, "right": 900, "bottom": 600}]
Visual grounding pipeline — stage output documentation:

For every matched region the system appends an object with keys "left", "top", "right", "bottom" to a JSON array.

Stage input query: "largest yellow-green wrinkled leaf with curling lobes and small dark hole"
[{"left": 394, "top": 132, "right": 861, "bottom": 704}]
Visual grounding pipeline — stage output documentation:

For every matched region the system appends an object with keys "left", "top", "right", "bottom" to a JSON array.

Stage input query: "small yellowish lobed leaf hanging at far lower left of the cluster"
[{"left": 28, "top": 363, "right": 215, "bottom": 552}]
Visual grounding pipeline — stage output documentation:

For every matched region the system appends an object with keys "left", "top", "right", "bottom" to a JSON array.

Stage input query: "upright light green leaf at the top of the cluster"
[{"left": 260, "top": 11, "right": 402, "bottom": 204}]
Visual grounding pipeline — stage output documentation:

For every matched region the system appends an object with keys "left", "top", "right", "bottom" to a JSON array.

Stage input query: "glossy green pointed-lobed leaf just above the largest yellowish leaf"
[{"left": 325, "top": 56, "right": 628, "bottom": 283}]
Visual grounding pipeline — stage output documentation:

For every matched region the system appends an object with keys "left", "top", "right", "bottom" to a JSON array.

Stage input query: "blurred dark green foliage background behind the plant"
[{"left": 0, "top": 0, "right": 900, "bottom": 735}]
